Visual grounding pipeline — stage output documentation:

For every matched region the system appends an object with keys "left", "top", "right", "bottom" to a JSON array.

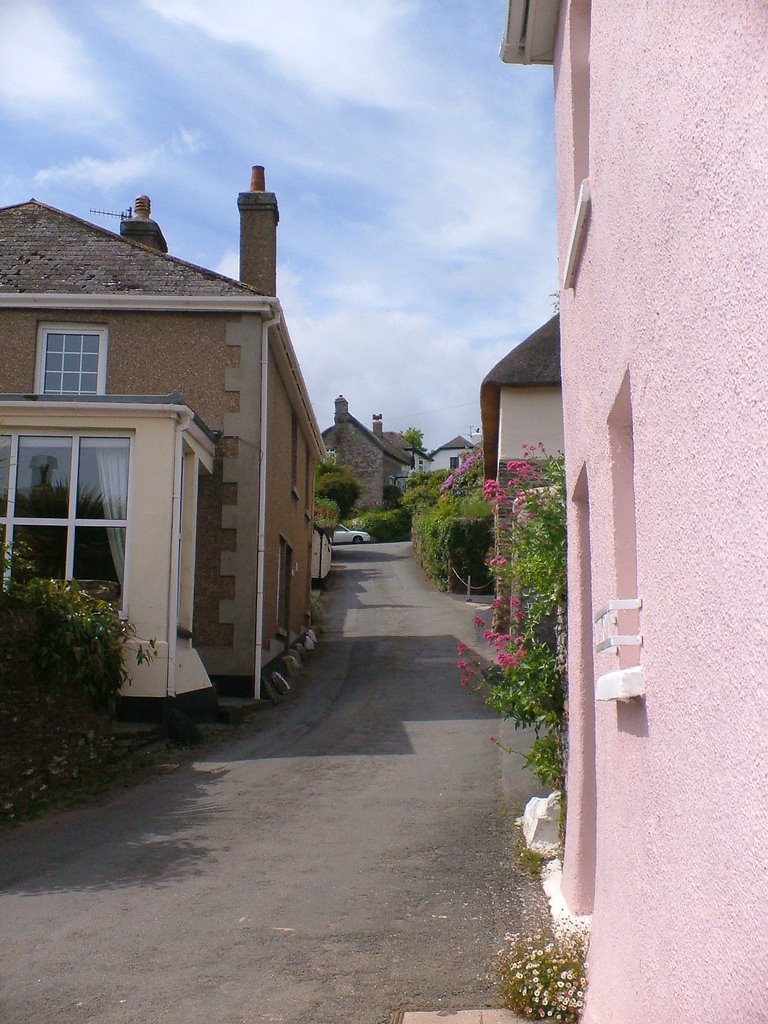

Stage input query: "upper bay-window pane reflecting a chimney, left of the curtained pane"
[{"left": 15, "top": 437, "right": 72, "bottom": 519}]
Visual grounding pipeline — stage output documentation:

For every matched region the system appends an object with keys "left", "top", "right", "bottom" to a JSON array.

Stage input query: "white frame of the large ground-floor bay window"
[{"left": 0, "top": 427, "right": 135, "bottom": 618}]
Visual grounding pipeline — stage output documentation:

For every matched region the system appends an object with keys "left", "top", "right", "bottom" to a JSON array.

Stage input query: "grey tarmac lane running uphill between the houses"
[{"left": 0, "top": 544, "right": 539, "bottom": 1024}]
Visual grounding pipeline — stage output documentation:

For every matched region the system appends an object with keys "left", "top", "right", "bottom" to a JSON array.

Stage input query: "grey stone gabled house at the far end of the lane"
[{"left": 323, "top": 395, "right": 413, "bottom": 508}]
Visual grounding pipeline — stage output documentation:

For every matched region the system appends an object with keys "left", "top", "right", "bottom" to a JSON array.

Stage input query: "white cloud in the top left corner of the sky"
[{"left": 0, "top": 0, "right": 114, "bottom": 123}]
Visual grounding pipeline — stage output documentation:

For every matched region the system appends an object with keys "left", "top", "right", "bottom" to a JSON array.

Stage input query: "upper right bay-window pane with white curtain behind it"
[{"left": 77, "top": 437, "right": 130, "bottom": 519}]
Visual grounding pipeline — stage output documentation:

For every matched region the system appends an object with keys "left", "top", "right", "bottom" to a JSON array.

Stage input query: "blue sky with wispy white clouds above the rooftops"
[{"left": 0, "top": 0, "right": 557, "bottom": 446}]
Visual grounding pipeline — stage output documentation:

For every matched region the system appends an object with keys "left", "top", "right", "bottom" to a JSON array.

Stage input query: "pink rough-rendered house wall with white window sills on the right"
[{"left": 502, "top": 0, "right": 768, "bottom": 1024}]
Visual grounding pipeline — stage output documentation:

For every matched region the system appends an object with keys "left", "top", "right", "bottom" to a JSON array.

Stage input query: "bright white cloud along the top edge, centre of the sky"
[{"left": 144, "top": 0, "right": 420, "bottom": 109}]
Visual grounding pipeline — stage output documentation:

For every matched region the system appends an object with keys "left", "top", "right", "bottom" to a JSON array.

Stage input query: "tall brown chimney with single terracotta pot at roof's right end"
[{"left": 238, "top": 166, "right": 280, "bottom": 295}]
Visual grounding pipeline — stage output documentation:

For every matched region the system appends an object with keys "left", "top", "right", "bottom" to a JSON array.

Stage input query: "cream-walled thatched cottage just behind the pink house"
[{"left": 480, "top": 315, "right": 563, "bottom": 483}]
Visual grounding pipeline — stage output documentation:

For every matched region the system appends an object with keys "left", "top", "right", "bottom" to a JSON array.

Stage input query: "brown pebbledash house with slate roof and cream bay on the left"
[{"left": 0, "top": 168, "right": 324, "bottom": 717}]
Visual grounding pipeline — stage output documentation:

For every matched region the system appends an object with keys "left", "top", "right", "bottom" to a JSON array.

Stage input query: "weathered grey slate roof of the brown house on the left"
[{"left": 0, "top": 199, "right": 257, "bottom": 303}]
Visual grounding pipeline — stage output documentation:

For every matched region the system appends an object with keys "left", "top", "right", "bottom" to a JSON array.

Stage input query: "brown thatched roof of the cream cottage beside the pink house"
[{"left": 480, "top": 313, "right": 560, "bottom": 479}]
